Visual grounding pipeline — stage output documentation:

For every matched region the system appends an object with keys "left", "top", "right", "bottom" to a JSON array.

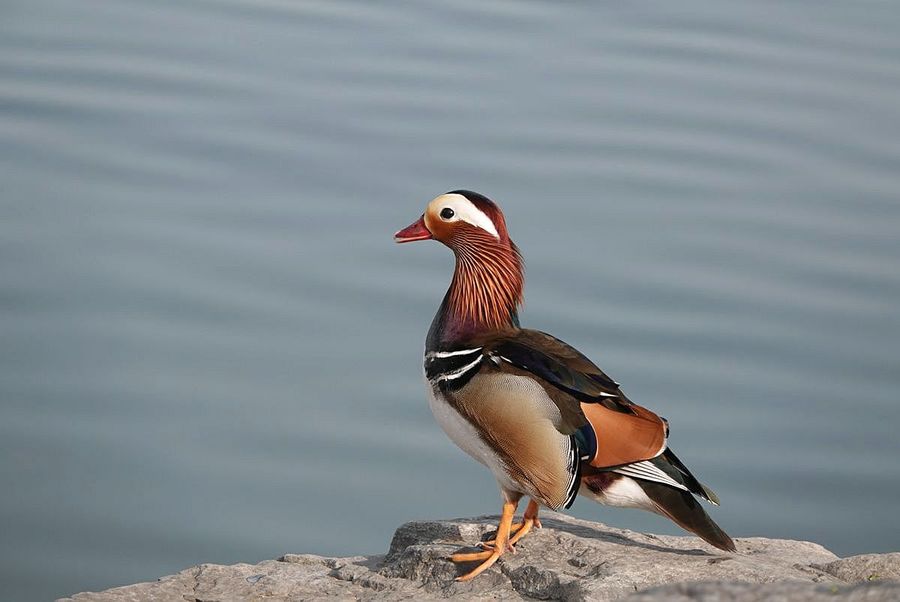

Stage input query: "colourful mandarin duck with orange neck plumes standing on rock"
[{"left": 394, "top": 190, "right": 735, "bottom": 581}]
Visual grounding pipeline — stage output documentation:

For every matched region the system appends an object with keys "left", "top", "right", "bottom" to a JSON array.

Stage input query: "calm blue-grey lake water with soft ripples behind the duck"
[{"left": 0, "top": 0, "right": 900, "bottom": 600}]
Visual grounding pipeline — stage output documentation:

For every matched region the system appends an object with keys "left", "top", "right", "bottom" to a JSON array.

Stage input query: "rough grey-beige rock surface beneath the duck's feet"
[{"left": 63, "top": 513, "right": 900, "bottom": 602}]
